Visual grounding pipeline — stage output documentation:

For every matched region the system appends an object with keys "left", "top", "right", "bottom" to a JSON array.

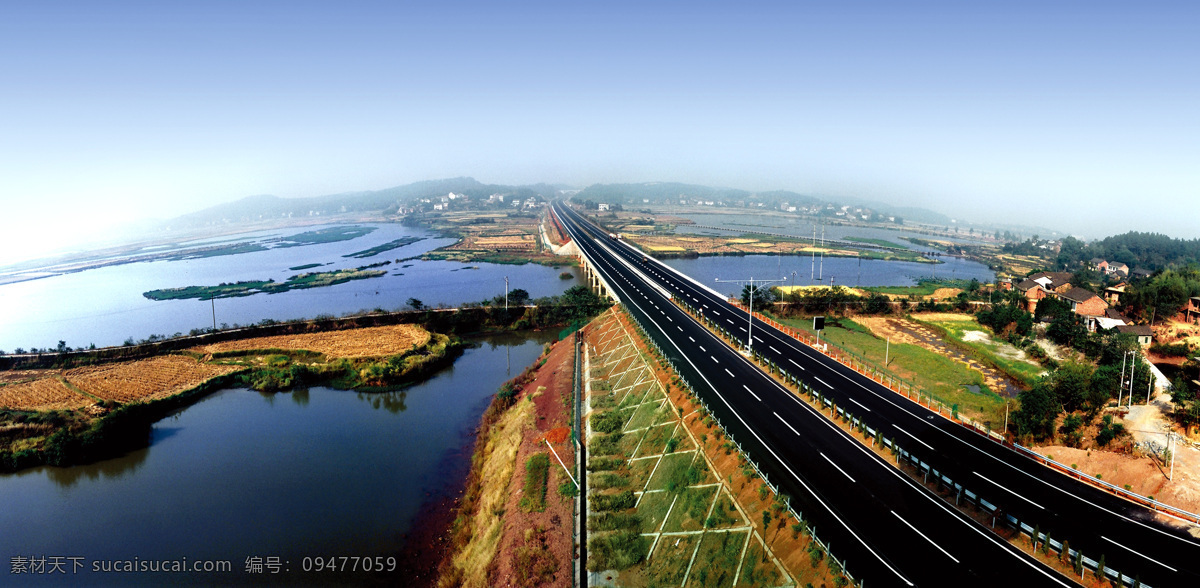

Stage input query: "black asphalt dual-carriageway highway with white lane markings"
[{"left": 554, "top": 203, "right": 1200, "bottom": 587}]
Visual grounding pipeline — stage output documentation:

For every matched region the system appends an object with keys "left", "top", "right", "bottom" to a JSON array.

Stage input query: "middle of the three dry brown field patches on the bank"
[{"left": 64, "top": 355, "right": 242, "bottom": 402}]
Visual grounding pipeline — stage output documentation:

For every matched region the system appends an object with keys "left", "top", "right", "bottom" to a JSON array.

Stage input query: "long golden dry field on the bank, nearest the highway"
[{"left": 194, "top": 324, "right": 430, "bottom": 358}]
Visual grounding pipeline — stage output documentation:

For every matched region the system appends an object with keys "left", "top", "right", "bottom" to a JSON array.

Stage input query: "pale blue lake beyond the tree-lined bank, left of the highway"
[{"left": 0, "top": 223, "right": 583, "bottom": 353}]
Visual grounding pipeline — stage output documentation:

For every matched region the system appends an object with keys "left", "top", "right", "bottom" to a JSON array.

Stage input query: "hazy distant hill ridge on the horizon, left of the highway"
[{"left": 169, "top": 178, "right": 559, "bottom": 228}]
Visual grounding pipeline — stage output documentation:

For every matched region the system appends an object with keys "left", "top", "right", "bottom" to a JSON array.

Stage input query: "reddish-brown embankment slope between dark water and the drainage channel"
[{"left": 438, "top": 338, "right": 575, "bottom": 587}]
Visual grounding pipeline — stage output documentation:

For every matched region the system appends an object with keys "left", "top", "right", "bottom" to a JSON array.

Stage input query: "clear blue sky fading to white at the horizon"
[{"left": 0, "top": 1, "right": 1200, "bottom": 262}]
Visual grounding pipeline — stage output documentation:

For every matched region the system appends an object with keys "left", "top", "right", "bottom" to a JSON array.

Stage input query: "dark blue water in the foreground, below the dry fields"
[{"left": 0, "top": 331, "right": 557, "bottom": 586}]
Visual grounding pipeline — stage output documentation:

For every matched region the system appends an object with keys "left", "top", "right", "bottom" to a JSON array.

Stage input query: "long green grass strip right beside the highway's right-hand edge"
[{"left": 781, "top": 318, "right": 1004, "bottom": 428}]
